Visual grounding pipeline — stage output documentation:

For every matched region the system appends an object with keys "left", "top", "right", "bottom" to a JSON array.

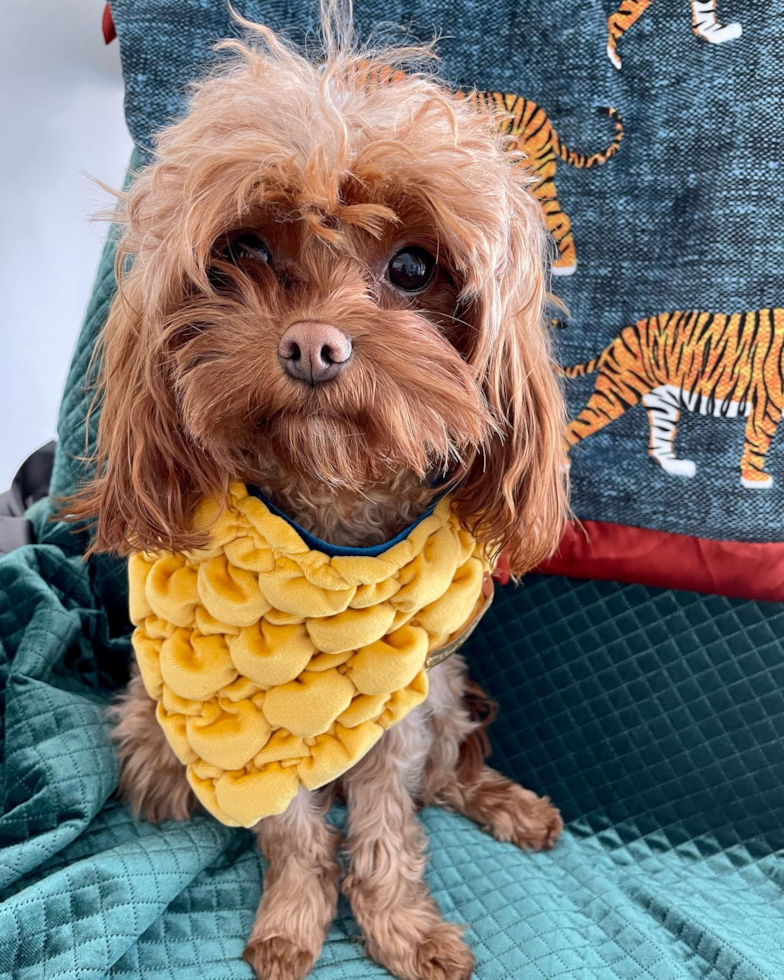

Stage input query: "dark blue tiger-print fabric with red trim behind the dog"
[{"left": 82, "top": 0, "right": 784, "bottom": 599}]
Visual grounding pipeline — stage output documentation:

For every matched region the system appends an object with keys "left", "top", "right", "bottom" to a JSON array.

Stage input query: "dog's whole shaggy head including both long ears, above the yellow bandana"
[{"left": 76, "top": 36, "right": 564, "bottom": 570}]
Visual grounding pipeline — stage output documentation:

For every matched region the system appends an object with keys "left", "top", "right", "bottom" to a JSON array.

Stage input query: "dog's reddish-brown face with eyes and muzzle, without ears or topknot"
[{"left": 174, "top": 175, "right": 493, "bottom": 491}]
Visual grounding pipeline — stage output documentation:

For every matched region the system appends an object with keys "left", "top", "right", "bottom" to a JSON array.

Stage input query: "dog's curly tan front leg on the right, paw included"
[{"left": 343, "top": 712, "right": 474, "bottom": 980}]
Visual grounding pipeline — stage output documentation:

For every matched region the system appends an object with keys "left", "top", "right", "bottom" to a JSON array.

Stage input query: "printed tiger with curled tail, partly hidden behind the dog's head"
[{"left": 358, "top": 65, "right": 623, "bottom": 276}]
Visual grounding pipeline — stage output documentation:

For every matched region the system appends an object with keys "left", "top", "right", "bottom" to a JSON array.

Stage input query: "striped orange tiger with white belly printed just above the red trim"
[{"left": 563, "top": 309, "right": 784, "bottom": 489}]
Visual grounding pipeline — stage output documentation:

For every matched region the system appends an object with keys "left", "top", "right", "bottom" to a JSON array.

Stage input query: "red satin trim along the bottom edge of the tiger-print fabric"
[{"left": 538, "top": 521, "right": 784, "bottom": 602}]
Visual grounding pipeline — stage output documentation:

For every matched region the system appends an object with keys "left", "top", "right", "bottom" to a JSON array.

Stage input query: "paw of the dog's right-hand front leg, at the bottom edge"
[{"left": 368, "top": 922, "right": 474, "bottom": 980}]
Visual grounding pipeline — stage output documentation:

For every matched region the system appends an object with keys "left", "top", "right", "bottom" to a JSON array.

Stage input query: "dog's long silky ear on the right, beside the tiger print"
[{"left": 457, "top": 187, "right": 568, "bottom": 576}]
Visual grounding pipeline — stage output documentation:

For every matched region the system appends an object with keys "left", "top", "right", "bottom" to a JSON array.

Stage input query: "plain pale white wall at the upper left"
[{"left": 0, "top": 0, "right": 131, "bottom": 490}]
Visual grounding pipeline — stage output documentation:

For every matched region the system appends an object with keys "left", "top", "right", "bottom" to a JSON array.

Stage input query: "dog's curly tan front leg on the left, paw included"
[{"left": 244, "top": 790, "right": 340, "bottom": 980}]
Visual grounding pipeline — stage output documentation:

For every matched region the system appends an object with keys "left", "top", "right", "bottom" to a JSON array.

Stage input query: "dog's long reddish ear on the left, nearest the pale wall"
[{"left": 59, "top": 256, "right": 219, "bottom": 554}]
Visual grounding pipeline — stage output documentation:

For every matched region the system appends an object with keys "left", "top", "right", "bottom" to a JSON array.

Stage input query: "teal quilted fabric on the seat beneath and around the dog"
[{"left": 0, "top": 528, "right": 784, "bottom": 980}]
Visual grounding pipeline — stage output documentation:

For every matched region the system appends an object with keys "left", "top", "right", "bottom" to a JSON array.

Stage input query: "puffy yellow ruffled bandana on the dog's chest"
[{"left": 129, "top": 484, "right": 490, "bottom": 827}]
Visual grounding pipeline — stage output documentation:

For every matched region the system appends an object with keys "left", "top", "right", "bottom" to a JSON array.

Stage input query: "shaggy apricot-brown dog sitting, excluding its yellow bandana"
[{"left": 65, "top": 5, "right": 567, "bottom": 980}]
